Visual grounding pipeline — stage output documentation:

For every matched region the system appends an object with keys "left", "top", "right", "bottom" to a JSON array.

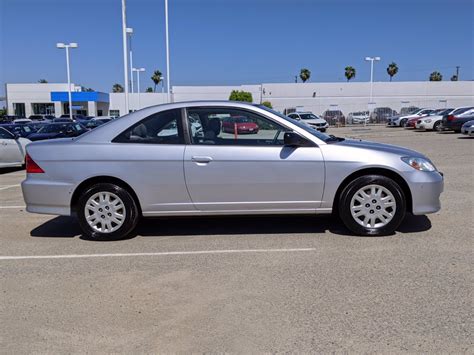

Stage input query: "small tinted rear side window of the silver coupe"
[{"left": 113, "top": 109, "right": 184, "bottom": 144}]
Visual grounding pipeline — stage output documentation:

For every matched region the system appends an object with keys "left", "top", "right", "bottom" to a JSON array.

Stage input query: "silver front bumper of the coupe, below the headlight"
[{"left": 408, "top": 171, "right": 444, "bottom": 215}]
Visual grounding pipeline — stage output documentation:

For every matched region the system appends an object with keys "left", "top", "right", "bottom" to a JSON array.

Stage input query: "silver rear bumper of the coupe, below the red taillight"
[{"left": 21, "top": 177, "right": 75, "bottom": 216}]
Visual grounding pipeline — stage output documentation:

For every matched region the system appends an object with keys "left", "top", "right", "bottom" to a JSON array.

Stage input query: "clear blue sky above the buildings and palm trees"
[{"left": 0, "top": 0, "right": 474, "bottom": 96}]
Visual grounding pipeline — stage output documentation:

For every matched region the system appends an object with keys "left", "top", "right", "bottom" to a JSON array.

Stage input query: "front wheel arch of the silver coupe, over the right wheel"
[{"left": 332, "top": 167, "right": 413, "bottom": 213}]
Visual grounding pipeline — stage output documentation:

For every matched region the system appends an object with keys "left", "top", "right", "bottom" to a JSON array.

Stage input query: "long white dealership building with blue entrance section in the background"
[{"left": 6, "top": 81, "right": 474, "bottom": 117}]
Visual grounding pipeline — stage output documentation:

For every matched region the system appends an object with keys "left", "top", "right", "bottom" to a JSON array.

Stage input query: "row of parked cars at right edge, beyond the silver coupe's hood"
[{"left": 387, "top": 106, "right": 474, "bottom": 135}]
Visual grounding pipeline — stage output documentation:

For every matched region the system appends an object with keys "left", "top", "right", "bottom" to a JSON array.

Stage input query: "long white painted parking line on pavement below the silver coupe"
[{"left": 0, "top": 248, "right": 316, "bottom": 261}]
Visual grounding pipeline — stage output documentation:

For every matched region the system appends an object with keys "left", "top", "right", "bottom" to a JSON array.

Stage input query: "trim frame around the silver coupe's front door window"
[{"left": 183, "top": 106, "right": 318, "bottom": 148}]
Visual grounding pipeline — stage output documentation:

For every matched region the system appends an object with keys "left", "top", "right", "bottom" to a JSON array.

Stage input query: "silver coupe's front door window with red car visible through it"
[{"left": 187, "top": 107, "right": 287, "bottom": 146}]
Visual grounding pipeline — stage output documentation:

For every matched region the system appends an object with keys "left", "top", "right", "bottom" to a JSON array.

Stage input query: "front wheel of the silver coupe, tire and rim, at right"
[{"left": 339, "top": 175, "right": 406, "bottom": 236}]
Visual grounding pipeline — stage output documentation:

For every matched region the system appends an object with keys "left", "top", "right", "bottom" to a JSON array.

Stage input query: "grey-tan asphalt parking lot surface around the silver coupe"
[{"left": 0, "top": 126, "right": 474, "bottom": 353}]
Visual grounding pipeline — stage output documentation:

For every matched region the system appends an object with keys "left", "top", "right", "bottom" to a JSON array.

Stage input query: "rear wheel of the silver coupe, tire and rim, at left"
[{"left": 77, "top": 183, "right": 140, "bottom": 241}]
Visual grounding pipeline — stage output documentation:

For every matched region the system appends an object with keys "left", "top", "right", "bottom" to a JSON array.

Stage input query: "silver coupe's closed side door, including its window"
[{"left": 184, "top": 107, "right": 324, "bottom": 213}]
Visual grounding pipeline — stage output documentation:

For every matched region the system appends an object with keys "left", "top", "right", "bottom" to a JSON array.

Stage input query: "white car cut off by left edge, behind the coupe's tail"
[{"left": 0, "top": 127, "right": 30, "bottom": 168}]
